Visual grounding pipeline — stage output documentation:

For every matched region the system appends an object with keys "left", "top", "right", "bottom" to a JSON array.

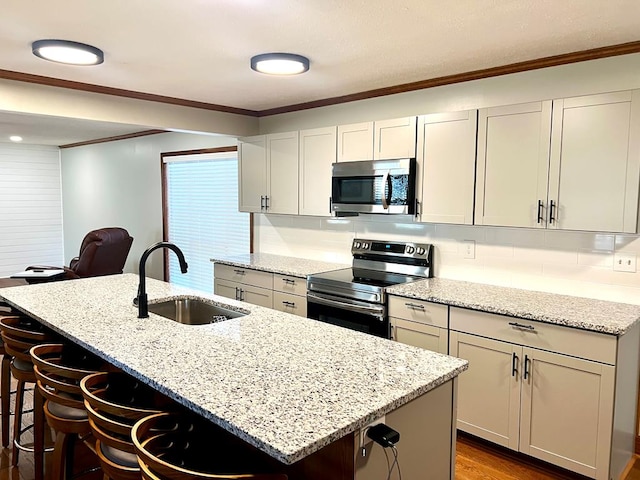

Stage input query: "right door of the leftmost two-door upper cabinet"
[{"left": 267, "top": 132, "right": 298, "bottom": 215}]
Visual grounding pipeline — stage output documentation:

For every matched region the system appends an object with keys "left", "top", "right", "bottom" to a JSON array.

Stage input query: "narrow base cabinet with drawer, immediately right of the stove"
[{"left": 388, "top": 295, "right": 449, "bottom": 354}]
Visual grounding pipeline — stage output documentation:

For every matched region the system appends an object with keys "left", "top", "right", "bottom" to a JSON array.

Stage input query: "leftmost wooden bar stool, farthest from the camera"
[{"left": 0, "top": 316, "right": 57, "bottom": 466}]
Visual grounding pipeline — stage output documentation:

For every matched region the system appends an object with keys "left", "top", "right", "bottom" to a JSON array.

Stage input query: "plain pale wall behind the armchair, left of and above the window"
[{"left": 61, "top": 133, "right": 237, "bottom": 282}]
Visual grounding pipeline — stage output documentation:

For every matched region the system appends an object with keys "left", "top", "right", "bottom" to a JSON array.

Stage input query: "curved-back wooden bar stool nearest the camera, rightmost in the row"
[{"left": 131, "top": 413, "right": 288, "bottom": 480}]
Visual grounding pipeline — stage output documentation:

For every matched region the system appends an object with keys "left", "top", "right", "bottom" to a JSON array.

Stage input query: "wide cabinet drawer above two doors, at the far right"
[{"left": 450, "top": 307, "right": 617, "bottom": 365}]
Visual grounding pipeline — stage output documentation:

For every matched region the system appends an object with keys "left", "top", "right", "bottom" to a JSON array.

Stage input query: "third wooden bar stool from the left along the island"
[{"left": 80, "top": 372, "right": 172, "bottom": 480}]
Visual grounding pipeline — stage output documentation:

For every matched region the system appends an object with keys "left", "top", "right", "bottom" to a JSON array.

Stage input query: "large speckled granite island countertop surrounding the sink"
[{"left": 0, "top": 274, "right": 468, "bottom": 464}]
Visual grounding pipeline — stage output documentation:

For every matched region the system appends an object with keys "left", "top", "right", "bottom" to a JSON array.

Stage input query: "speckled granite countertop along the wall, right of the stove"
[{"left": 387, "top": 278, "right": 640, "bottom": 335}]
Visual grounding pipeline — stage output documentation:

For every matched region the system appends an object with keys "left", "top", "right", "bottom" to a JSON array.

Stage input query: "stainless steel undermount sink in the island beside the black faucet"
[{"left": 149, "top": 298, "right": 246, "bottom": 325}]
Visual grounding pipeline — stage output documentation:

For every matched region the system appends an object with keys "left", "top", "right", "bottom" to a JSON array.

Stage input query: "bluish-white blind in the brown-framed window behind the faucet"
[{"left": 164, "top": 152, "right": 249, "bottom": 293}]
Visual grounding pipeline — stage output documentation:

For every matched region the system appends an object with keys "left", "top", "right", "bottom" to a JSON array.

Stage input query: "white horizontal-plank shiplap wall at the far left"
[{"left": 0, "top": 143, "right": 64, "bottom": 277}]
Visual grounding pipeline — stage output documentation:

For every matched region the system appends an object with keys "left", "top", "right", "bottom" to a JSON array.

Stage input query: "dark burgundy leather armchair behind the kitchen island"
[{"left": 27, "top": 227, "right": 133, "bottom": 280}]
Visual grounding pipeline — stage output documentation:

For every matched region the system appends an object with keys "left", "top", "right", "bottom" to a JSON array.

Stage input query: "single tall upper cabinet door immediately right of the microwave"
[{"left": 417, "top": 110, "right": 478, "bottom": 225}]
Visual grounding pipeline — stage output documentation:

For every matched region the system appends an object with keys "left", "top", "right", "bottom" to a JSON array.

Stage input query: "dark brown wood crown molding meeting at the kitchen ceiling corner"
[{"left": 0, "top": 41, "right": 640, "bottom": 117}]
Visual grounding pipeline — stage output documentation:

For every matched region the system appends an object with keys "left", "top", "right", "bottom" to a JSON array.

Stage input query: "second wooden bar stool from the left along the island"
[{"left": 30, "top": 344, "right": 106, "bottom": 480}]
